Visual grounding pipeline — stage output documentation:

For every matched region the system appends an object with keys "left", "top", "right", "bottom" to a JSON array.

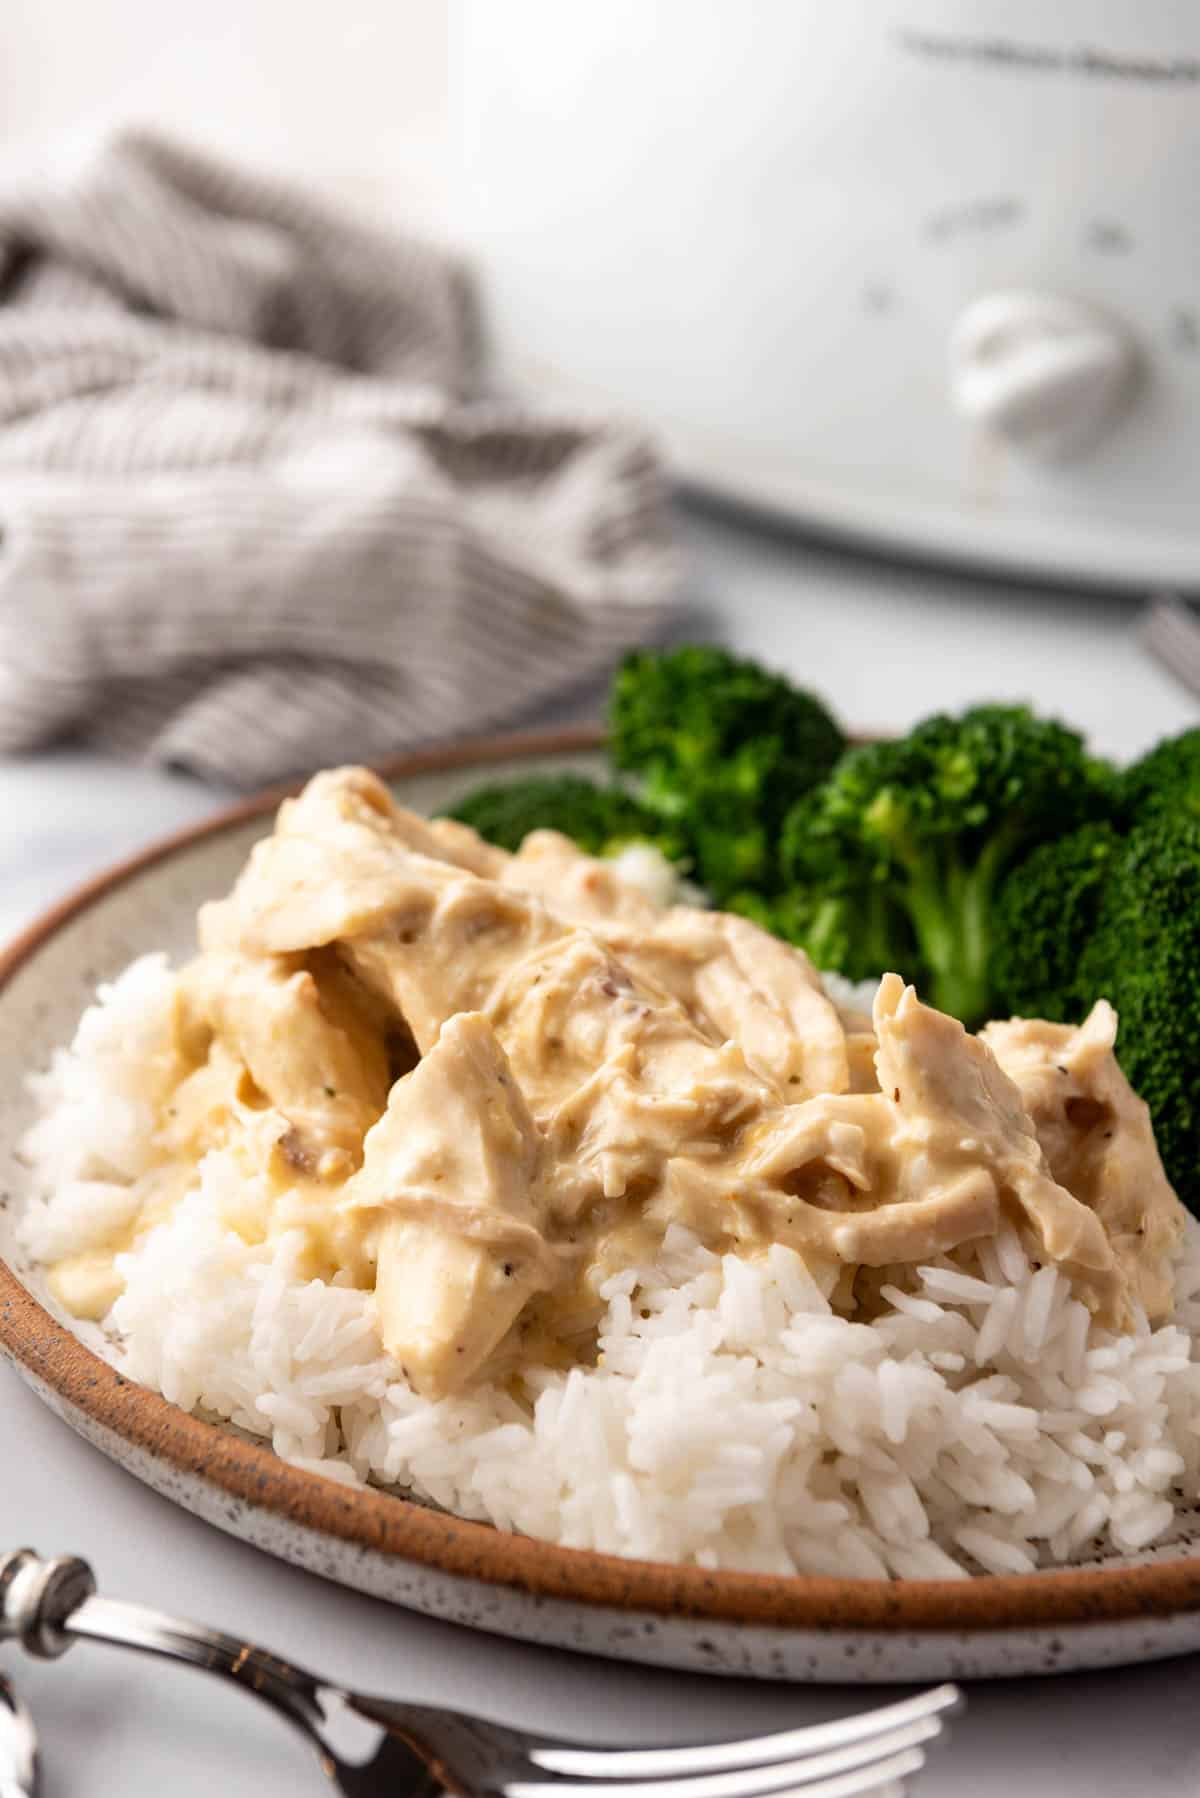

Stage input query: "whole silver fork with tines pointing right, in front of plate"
[{"left": 0, "top": 1548, "right": 963, "bottom": 1798}]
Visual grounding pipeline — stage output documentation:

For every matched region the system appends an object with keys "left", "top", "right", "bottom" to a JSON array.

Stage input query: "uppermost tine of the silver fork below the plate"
[{"left": 529, "top": 1685, "right": 963, "bottom": 1780}]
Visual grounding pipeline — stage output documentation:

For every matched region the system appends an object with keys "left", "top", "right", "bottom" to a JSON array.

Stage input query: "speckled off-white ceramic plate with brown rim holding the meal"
[{"left": 0, "top": 732, "right": 1200, "bottom": 1681}]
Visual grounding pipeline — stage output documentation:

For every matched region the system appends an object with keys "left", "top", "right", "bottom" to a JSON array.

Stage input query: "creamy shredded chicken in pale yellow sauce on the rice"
[{"left": 54, "top": 768, "right": 1184, "bottom": 1395}]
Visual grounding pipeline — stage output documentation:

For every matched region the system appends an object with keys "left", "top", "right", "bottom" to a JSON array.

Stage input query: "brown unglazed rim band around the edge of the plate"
[{"left": 0, "top": 728, "right": 1200, "bottom": 1634}]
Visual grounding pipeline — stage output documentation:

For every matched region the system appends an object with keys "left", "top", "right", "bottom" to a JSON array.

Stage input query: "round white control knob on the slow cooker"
[{"left": 950, "top": 291, "right": 1137, "bottom": 460}]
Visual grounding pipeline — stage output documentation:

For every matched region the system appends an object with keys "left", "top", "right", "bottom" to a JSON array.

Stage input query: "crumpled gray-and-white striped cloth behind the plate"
[{"left": 0, "top": 133, "right": 678, "bottom": 786}]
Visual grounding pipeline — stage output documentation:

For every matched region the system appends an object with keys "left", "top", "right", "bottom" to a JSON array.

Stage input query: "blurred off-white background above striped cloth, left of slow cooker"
[{"left": 0, "top": 0, "right": 452, "bottom": 232}]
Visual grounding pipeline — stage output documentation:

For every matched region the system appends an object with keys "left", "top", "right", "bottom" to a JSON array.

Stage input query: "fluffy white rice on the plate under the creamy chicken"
[{"left": 22, "top": 957, "right": 1200, "bottom": 1579}]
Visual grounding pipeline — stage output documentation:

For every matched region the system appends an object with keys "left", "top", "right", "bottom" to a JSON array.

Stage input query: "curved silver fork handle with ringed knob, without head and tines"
[{"left": 0, "top": 1548, "right": 329, "bottom": 1735}]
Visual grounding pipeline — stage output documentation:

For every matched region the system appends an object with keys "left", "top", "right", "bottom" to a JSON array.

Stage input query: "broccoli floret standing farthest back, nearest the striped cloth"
[{"left": 608, "top": 644, "right": 846, "bottom": 903}]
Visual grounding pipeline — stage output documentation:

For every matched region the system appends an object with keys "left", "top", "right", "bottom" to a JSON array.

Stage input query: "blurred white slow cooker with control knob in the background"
[{"left": 452, "top": 0, "right": 1200, "bottom": 586}]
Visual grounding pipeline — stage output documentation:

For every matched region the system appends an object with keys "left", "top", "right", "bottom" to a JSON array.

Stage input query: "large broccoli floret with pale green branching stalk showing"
[{"left": 788, "top": 705, "right": 1112, "bottom": 1028}]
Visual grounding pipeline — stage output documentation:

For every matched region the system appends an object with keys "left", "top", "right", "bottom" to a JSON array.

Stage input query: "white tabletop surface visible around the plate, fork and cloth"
[{"left": 0, "top": 518, "right": 1200, "bottom": 1798}]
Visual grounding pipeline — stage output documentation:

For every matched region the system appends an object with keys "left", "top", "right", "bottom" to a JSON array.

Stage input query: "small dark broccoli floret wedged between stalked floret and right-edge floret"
[{"left": 991, "top": 823, "right": 1123, "bottom": 1023}]
